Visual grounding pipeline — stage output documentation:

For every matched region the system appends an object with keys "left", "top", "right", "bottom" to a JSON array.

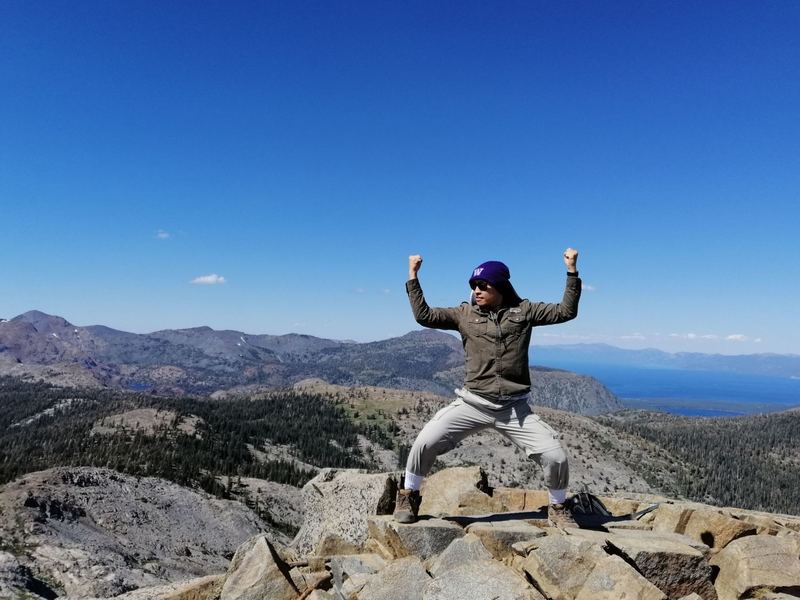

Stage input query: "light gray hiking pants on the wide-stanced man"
[{"left": 406, "top": 390, "right": 569, "bottom": 490}]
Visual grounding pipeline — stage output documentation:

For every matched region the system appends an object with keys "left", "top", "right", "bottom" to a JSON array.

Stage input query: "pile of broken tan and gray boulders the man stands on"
[{"left": 6, "top": 467, "right": 800, "bottom": 600}]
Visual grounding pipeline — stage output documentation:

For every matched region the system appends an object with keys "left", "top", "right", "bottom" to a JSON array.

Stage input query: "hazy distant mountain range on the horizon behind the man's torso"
[{"left": 0, "top": 311, "right": 621, "bottom": 414}]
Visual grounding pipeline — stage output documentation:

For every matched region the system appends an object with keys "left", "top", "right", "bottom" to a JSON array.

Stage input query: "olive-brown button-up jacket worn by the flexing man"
[{"left": 406, "top": 276, "right": 581, "bottom": 403}]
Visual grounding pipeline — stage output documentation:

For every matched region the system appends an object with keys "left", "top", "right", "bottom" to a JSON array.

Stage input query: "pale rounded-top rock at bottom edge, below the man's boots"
[{"left": 422, "top": 560, "right": 545, "bottom": 600}]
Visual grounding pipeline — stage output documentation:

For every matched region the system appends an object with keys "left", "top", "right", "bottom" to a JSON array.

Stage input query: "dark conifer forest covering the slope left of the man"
[{"left": 0, "top": 378, "right": 391, "bottom": 496}]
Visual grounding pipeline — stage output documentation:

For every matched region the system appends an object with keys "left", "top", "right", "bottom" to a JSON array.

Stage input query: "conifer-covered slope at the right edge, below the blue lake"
[{"left": 597, "top": 411, "right": 800, "bottom": 514}]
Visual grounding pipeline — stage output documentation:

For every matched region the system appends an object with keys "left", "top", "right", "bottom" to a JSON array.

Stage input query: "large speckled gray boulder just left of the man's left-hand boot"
[{"left": 291, "top": 469, "right": 397, "bottom": 554}]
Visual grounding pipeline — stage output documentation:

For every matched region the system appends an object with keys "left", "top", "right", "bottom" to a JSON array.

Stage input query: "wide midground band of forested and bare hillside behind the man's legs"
[{"left": 6, "top": 378, "right": 800, "bottom": 514}]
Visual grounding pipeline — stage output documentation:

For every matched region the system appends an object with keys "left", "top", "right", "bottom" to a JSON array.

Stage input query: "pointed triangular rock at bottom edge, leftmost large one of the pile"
[{"left": 220, "top": 535, "right": 299, "bottom": 600}]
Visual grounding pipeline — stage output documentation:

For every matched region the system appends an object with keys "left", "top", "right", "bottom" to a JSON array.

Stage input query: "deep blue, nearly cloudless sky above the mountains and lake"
[{"left": 0, "top": 0, "right": 800, "bottom": 353}]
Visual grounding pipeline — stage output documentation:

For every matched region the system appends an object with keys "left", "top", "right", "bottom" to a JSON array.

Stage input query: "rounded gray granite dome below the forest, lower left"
[{"left": 0, "top": 467, "right": 268, "bottom": 598}]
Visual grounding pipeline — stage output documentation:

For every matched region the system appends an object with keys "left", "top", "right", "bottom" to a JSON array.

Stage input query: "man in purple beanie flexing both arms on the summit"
[{"left": 394, "top": 248, "right": 581, "bottom": 526}]
